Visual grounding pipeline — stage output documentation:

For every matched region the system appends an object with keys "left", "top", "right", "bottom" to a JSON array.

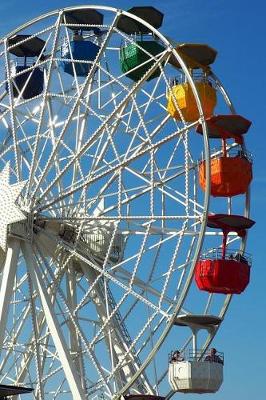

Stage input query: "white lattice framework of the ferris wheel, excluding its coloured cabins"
[{"left": 0, "top": 6, "right": 248, "bottom": 400}]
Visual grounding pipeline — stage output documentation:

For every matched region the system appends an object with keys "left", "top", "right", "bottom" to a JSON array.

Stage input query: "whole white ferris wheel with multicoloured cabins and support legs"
[{"left": 0, "top": 6, "right": 254, "bottom": 400}]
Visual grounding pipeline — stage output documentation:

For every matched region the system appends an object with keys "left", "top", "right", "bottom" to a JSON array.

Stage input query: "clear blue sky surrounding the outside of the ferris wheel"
[{"left": 0, "top": 0, "right": 266, "bottom": 400}]
